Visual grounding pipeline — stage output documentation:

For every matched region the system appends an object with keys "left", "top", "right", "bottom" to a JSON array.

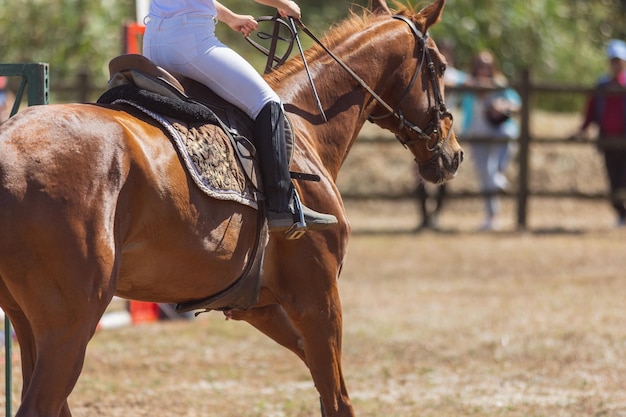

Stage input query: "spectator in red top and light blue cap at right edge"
[{"left": 572, "top": 40, "right": 626, "bottom": 227}]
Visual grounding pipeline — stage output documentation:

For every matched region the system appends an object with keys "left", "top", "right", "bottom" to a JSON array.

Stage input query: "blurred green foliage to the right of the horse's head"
[{"left": 432, "top": 0, "right": 626, "bottom": 84}]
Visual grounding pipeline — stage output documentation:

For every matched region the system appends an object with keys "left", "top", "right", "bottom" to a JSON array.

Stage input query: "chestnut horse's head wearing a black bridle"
[{"left": 370, "top": 0, "right": 463, "bottom": 183}]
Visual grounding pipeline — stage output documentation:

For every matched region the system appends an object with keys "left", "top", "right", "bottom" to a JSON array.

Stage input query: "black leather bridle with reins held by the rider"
[{"left": 250, "top": 15, "right": 453, "bottom": 152}]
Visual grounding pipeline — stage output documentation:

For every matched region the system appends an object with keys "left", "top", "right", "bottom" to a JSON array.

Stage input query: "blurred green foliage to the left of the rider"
[{"left": 0, "top": 0, "right": 135, "bottom": 86}]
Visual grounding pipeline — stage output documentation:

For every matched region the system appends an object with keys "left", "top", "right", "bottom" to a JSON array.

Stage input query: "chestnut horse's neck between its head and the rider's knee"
[{"left": 274, "top": 17, "right": 399, "bottom": 180}]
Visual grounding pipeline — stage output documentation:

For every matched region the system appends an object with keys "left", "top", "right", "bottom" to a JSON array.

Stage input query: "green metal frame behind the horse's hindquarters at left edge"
[{"left": 0, "top": 63, "right": 50, "bottom": 417}]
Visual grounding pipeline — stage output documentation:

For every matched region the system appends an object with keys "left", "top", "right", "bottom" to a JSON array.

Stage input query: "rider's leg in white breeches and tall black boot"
[{"left": 144, "top": 21, "right": 337, "bottom": 231}]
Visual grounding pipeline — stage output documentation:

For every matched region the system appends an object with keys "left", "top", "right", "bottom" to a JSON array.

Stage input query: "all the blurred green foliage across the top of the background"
[{"left": 0, "top": 0, "right": 626, "bottom": 109}]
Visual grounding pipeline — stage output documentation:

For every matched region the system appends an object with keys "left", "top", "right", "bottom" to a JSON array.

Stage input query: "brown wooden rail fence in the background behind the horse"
[{"left": 51, "top": 71, "right": 626, "bottom": 229}]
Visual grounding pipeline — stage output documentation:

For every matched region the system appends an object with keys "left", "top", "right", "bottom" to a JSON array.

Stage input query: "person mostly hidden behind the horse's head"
[{"left": 416, "top": 40, "right": 467, "bottom": 231}]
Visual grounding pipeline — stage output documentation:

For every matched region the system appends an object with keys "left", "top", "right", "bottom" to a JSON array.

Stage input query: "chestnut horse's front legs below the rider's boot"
[{"left": 233, "top": 229, "right": 354, "bottom": 417}]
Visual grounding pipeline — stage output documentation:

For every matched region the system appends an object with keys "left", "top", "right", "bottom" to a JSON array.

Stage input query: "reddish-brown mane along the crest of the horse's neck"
[{"left": 266, "top": 7, "right": 416, "bottom": 85}]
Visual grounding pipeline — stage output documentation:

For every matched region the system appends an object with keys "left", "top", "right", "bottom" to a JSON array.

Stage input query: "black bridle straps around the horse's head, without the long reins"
[{"left": 366, "top": 15, "right": 454, "bottom": 152}]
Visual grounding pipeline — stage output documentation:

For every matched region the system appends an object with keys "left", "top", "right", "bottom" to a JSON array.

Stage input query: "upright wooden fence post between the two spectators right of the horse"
[{"left": 517, "top": 69, "right": 531, "bottom": 230}]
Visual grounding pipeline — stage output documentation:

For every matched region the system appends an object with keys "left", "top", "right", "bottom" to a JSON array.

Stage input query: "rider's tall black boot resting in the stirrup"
[{"left": 254, "top": 102, "right": 337, "bottom": 231}]
